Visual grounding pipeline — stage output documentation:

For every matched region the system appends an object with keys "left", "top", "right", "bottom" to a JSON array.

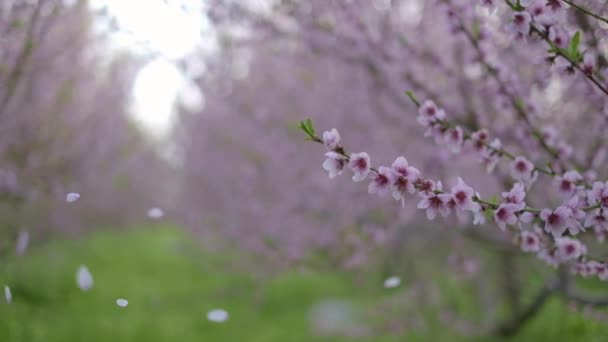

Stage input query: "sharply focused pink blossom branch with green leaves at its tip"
[{"left": 300, "top": 120, "right": 608, "bottom": 280}]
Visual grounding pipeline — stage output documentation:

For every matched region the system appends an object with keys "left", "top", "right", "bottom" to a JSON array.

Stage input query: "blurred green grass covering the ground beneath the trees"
[{"left": 0, "top": 228, "right": 608, "bottom": 342}]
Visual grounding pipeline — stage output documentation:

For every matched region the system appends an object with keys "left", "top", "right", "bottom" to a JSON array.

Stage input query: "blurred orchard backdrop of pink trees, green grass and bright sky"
[{"left": 0, "top": 0, "right": 608, "bottom": 342}]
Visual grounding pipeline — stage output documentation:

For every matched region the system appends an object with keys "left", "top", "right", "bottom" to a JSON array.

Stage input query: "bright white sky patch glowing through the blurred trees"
[{"left": 91, "top": 0, "right": 206, "bottom": 136}]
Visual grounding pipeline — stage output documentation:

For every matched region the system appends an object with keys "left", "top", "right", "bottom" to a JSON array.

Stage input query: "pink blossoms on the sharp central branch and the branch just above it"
[{"left": 316, "top": 119, "right": 608, "bottom": 280}]
